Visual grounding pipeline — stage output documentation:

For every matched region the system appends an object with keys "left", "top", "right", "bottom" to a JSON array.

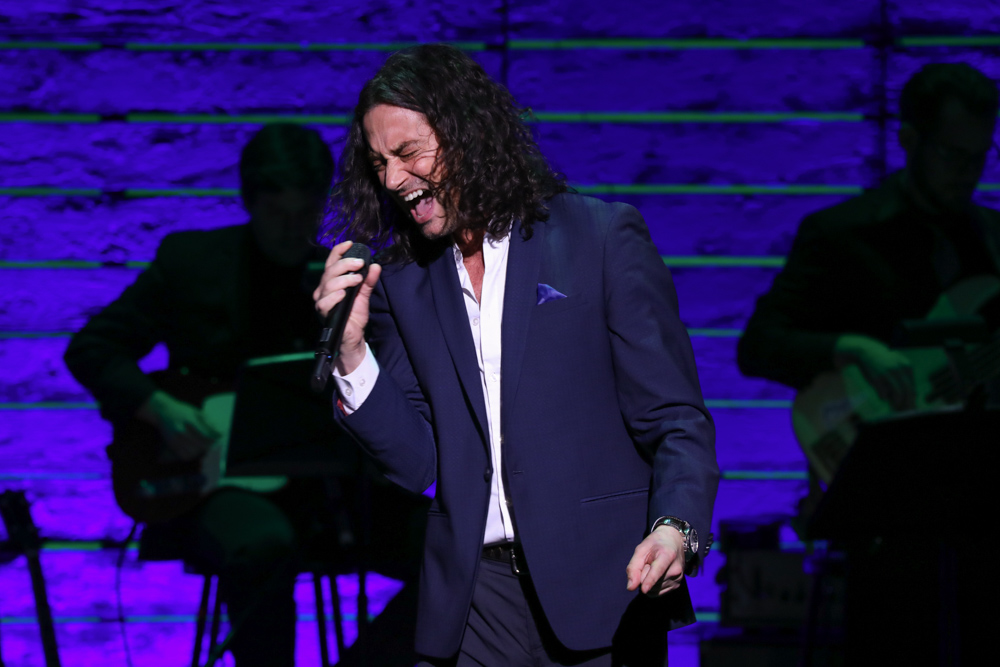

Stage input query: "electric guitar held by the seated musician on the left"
[{"left": 108, "top": 371, "right": 288, "bottom": 523}]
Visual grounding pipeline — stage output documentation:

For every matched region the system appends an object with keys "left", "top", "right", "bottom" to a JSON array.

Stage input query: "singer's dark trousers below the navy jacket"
[{"left": 420, "top": 559, "right": 667, "bottom": 667}]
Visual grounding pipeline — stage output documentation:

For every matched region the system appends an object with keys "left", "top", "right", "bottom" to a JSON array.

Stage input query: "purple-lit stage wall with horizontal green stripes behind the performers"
[{"left": 0, "top": 0, "right": 1000, "bottom": 666}]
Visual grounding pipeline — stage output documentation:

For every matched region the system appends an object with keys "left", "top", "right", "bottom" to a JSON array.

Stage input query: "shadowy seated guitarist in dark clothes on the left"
[{"left": 65, "top": 124, "right": 333, "bottom": 667}]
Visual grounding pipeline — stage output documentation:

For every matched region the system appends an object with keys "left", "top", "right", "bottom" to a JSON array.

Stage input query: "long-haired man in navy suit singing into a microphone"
[{"left": 314, "top": 45, "right": 718, "bottom": 665}]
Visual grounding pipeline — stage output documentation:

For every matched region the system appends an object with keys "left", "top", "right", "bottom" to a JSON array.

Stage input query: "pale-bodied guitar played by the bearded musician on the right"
[{"left": 792, "top": 276, "right": 1000, "bottom": 483}]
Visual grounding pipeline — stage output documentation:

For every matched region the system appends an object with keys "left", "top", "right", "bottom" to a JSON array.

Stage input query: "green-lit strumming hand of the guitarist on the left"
[{"left": 135, "top": 390, "right": 221, "bottom": 461}]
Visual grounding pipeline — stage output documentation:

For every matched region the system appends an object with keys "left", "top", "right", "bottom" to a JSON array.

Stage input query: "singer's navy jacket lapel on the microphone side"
[{"left": 428, "top": 247, "right": 490, "bottom": 443}]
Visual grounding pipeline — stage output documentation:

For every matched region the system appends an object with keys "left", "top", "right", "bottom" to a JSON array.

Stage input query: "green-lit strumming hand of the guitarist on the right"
[{"left": 834, "top": 334, "right": 916, "bottom": 411}]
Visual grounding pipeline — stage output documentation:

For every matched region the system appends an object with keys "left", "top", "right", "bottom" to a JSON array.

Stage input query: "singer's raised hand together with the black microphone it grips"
[{"left": 311, "top": 241, "right": 382, "bottom": 391}]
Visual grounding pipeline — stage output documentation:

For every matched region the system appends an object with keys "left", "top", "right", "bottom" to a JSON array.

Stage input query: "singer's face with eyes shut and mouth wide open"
[{"left": 364, "top": 104, "right": 457, "bottom": 239}]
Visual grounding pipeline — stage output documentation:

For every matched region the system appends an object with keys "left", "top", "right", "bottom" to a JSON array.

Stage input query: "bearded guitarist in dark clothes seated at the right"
[{"left": 738, "top": 63, "right": 1000, "bottom": 664}]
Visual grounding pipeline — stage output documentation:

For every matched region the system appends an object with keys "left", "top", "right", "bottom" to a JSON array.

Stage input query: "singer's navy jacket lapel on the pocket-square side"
[{"left": 500, "top": 223, "right": 545, "bottom": 430}]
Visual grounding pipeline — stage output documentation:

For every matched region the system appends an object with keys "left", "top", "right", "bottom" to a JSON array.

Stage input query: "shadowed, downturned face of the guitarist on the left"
[{"left": 246, "top": 188, "right": 325, "bottom": 266}]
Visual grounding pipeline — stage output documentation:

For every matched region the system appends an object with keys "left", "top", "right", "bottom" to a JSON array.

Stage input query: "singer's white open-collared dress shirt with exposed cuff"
[{"left": 333, "top": 234, "right": 514, "bottom": 544}]
